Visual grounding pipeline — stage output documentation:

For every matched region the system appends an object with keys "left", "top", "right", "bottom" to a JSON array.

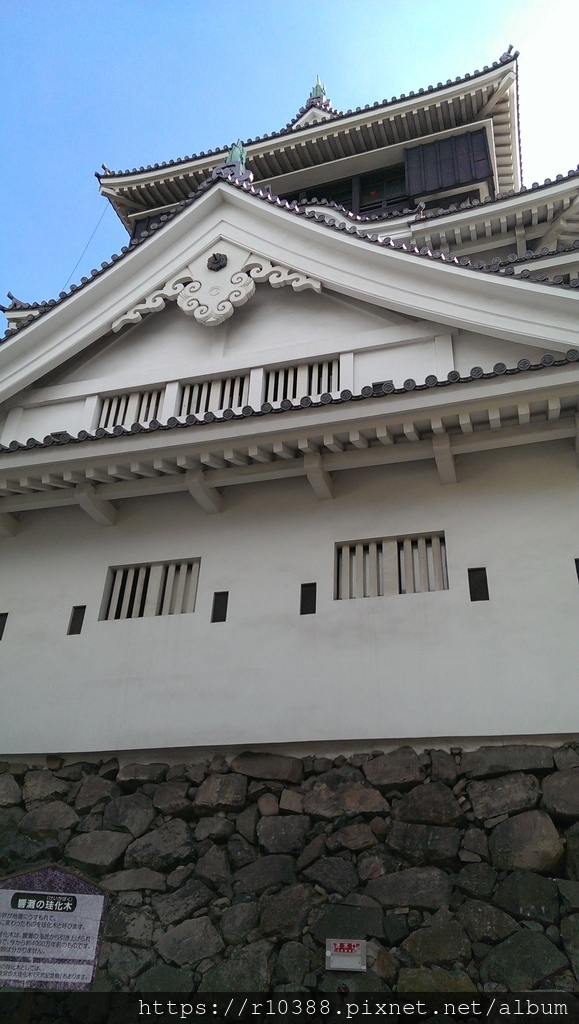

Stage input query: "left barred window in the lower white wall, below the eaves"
[{"left": 99, "top": 558, "right": 200, "bottom": 622}]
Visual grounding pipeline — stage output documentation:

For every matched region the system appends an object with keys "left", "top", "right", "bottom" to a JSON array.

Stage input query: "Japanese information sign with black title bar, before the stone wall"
[{"left": 0, "top": 866, "right": 106, "bottom": 990}]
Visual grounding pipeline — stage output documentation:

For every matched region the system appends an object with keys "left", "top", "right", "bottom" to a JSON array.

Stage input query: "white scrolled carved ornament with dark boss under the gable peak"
[{"left": 111, "top": 244, "right": 322, "bottom": 332}]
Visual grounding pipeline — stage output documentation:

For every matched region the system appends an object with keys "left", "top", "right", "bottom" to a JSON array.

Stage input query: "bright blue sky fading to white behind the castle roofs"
[{"left": 0, "top": 0, "right": 579, "bottom": 323}]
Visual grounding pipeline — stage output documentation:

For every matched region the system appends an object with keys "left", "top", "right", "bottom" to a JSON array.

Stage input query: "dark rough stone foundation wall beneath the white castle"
[{"left": 0, "top": 743, "right": 579, "bottom": 992}]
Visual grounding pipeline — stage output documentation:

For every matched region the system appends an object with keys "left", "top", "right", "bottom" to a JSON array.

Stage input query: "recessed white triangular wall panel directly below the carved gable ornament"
[{"left": 42, "top": 285, "right": 414, "bottom": 387}]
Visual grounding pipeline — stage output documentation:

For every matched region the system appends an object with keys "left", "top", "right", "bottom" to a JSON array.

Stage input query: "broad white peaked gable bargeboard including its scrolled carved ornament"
[{"left": 0, "top": 181, "right": 578, "bottom": 407}]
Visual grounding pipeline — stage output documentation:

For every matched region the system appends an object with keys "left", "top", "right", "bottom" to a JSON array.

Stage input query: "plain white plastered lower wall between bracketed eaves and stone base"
[{"left": 0, "top": 441, "right": 579, "bottom": 753}]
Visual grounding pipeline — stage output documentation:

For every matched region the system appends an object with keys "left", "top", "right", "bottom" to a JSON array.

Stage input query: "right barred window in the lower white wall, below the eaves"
[{"left": 334, "top": 534, "right": 448, "bottom": 601}]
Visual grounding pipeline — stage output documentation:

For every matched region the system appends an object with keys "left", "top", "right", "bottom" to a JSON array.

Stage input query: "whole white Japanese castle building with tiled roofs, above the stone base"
[{"left": 0, "top": 51, "right": 579, "bottom": 758}]
